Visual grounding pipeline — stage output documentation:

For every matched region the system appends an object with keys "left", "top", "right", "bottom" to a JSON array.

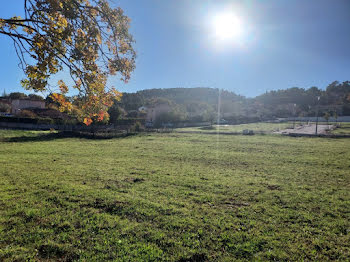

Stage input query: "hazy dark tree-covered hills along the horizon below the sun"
[{"left": 118, "top": 81, "right": 350, "bottom": 122}]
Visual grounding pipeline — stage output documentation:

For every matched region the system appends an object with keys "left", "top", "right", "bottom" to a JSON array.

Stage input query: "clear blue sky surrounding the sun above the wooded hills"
[{"left": 0, "top": 0, "right": 350, "bottom": 97}]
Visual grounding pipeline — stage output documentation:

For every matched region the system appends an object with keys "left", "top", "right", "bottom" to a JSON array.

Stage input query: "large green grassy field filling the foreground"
[{"left": 0, "top": 130, "right": 350, "bottom": 261}]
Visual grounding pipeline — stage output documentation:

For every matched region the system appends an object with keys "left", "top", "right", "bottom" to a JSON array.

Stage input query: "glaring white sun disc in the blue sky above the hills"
[{"left": 212, "top": 13, "right": 243, "bottom": 41}]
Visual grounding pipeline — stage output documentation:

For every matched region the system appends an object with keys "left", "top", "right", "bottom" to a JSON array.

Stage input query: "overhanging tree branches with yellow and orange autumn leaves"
[{"left": 0, "top": 0, "right": 136, "bottom": 124}]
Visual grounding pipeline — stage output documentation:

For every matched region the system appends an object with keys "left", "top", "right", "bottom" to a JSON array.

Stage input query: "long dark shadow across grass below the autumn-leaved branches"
[{"left": 0, "top": 131, "right": 138, "bottom": 143}]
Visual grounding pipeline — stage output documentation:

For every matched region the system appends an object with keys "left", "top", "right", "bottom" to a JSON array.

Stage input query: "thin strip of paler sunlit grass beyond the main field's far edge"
[{"left": 175, "top": 123, "right": 293, "bottom": 133}]
